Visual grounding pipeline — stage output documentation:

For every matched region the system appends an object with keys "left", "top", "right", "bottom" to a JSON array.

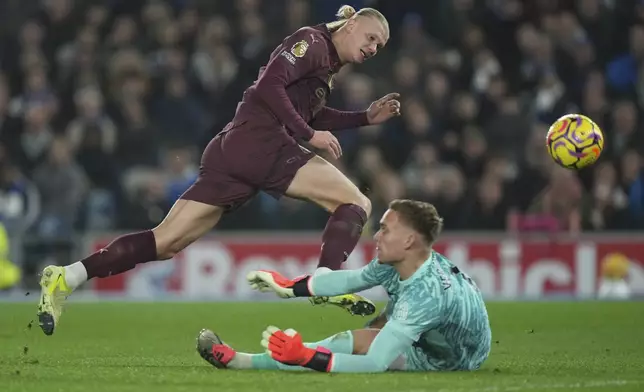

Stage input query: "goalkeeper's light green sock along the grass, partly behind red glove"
[{"left": 227, "top": 331, "right": 353, "bottom": 370}]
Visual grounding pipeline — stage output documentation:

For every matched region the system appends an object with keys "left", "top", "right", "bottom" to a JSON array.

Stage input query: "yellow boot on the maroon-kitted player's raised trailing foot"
[{"left": 38, "top": 265, "right": 72, "bottom": 335}]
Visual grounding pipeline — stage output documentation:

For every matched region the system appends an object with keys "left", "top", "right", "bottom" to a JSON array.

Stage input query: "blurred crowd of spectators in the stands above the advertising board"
[{"left": 0, "top": 0, "right": 644, "bottom": 242}]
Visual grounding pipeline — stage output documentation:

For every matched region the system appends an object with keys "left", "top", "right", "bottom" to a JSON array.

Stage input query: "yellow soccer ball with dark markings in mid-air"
[{"left": 546, "top": 114, "right": 604, "bottom": 169}]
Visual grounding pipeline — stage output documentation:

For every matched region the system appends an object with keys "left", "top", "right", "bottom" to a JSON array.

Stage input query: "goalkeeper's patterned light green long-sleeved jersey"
[{"left": 309, "top": 252, "right": 491, "bottom": 372}]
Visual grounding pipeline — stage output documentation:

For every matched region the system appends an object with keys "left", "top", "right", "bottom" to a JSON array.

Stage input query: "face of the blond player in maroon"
[{"left": 346, "top": 16, "right": 389, "bottom": 63}]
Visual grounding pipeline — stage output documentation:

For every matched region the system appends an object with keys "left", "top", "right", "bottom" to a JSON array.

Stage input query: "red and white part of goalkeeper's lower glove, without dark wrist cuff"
[{"left": 261, "top": 326, "right": 316, "bottom": 366}]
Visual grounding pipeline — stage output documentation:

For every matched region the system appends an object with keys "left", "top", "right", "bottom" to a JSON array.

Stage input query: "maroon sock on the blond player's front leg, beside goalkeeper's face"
[{"left": 318, "top": 204, "right": 367, "bottom": 271}]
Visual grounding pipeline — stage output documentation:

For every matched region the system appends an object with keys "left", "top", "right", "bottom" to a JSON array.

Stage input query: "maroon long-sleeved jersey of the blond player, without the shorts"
[{"left": 224, "top": 24, "right": 368, "bottom": 141}]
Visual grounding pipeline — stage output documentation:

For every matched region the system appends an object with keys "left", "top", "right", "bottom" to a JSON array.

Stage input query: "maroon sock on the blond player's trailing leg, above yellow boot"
[{"left": 81, "top": 230, "right": 157, "bottom": 279}]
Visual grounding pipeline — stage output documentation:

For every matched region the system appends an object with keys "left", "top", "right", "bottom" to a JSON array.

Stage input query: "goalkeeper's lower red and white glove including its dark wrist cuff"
[{"left": 262, "top": 326, "right": 332, "bottom": 372}]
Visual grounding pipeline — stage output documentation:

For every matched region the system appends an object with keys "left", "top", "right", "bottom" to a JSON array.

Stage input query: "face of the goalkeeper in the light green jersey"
[{"left": 374, "top": 210, "right": 413, "bottom": 264}]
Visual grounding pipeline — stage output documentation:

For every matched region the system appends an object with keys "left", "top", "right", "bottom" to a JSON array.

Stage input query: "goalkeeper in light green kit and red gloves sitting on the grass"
[{"left": 197, "top": 200, "right": 491, "bottom": 373}]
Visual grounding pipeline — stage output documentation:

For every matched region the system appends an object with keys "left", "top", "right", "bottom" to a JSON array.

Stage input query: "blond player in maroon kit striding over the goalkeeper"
[{"left": 38, "top": 6, "right": 400, "bottom": 335}]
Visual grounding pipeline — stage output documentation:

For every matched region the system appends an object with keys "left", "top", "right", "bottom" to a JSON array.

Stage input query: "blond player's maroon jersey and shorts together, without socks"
[{"left": 181, "top": 25, "right": 368, "bottom": 211}]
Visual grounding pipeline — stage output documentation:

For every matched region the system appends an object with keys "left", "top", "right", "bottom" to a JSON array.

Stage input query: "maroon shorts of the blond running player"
[{"left": 181, "top": 125, "right": 315, "bottom": 211}]
